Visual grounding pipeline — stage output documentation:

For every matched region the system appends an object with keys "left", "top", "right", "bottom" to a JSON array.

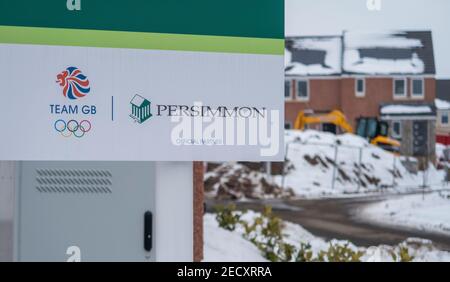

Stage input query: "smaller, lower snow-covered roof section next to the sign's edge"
[{"left": 285, "top": 36, "right": 342, "bottom": 76}]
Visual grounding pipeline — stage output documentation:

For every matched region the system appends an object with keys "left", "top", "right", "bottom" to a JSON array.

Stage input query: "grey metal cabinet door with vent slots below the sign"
[{"left": 16, "top": 162, "right": 155, "bottom": 261}]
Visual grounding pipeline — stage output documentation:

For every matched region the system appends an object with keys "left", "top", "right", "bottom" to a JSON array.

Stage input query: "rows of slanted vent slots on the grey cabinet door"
[{"left": 35, "top": 169, "right": 112, "bottom": 194}]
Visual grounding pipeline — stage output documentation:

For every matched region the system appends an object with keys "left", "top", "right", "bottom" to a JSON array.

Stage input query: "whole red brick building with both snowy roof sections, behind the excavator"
[{"left": 285, "top": 31, "right": 436, "bottom": 158}]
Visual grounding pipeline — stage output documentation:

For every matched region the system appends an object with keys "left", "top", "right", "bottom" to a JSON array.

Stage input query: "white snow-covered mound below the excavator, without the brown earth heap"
[{"left": 275, "top": 130, "right": 445, "bottom": 198}]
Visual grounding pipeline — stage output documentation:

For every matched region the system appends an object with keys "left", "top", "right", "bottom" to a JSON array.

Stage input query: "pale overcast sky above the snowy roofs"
[{"left": 285, "top": 0, "right": 450, "bottom": 78}]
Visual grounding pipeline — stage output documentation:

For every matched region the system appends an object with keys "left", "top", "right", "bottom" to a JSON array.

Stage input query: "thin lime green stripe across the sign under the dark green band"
[{"left": 0, "top": 26, "right": 284, "bottom": 55}]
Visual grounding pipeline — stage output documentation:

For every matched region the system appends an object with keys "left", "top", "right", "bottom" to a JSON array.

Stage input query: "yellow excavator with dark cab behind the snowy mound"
[{"left": 294, "top": 110, "right": 401, "bottom": 153}]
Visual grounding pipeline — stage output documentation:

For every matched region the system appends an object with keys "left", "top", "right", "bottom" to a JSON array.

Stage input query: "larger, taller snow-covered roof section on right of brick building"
[{"left": 342, "top": 31, "right": 435, "bottom": 75}]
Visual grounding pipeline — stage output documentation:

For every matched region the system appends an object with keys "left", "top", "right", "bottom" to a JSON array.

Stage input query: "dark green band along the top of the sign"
[{"left": 0, "top": 0, "right": 284, "bottom": 39}]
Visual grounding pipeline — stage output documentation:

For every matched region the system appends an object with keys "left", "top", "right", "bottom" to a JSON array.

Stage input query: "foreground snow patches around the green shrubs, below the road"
[{"left": 204, "top": 211, "right": 450, "bottom": 262}]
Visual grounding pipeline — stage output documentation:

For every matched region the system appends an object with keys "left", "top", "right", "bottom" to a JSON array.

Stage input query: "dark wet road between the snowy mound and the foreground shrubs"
[{"left": 207, "top": 196, "right": 450, "bottom": 251}]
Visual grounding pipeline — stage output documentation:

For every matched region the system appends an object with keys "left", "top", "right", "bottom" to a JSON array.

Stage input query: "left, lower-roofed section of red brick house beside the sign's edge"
[{"left": 284, "top": 36, "right": 342, "bottom": 128}]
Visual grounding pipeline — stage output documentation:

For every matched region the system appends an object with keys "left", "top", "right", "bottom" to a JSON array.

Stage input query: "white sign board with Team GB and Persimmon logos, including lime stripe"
[{"left": 0, "top": 1, "right": 284, "bottom": 161}]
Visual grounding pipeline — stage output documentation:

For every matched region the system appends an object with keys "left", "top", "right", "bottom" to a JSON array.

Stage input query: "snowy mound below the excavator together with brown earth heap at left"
[{"left": 205, "top": 130, "right": 445, "bottom": 200}]
